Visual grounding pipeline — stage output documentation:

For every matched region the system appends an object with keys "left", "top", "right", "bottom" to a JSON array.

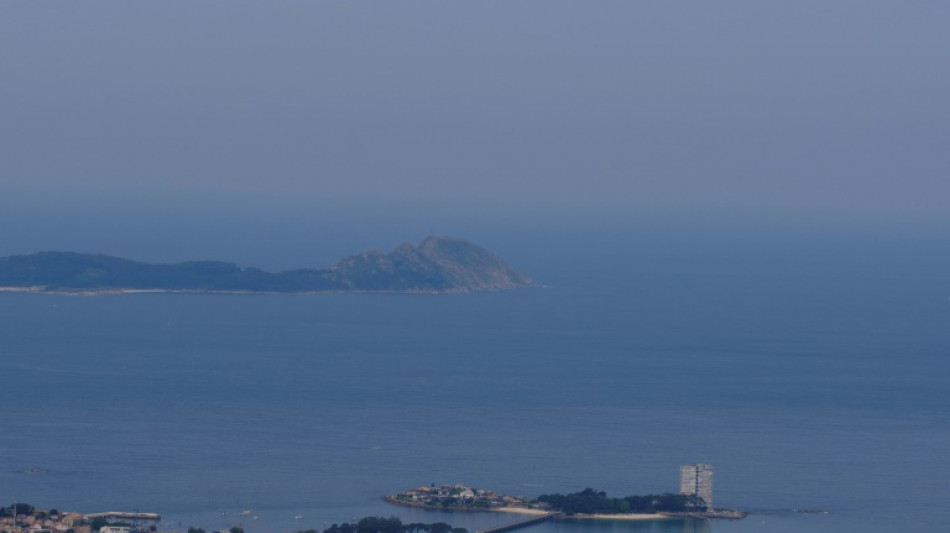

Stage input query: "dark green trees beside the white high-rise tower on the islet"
[{"left": 538, "top": 488, "right": 706, "bottom": 515}]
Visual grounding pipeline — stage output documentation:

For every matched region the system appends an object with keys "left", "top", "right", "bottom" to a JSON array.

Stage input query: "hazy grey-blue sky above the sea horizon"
[{"left": 0, "top": 0, "right": 950, "bottom": 264}]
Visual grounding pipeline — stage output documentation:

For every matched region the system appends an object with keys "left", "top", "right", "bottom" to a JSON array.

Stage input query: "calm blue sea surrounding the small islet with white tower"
[{"left": 0, "top": 234, "right": 950, "bottom": 533}]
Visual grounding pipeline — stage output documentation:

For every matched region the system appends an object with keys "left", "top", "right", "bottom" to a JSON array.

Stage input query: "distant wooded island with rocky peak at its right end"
[{"left": 0, "top": 237, "right": 534, "bottom": 293}]
